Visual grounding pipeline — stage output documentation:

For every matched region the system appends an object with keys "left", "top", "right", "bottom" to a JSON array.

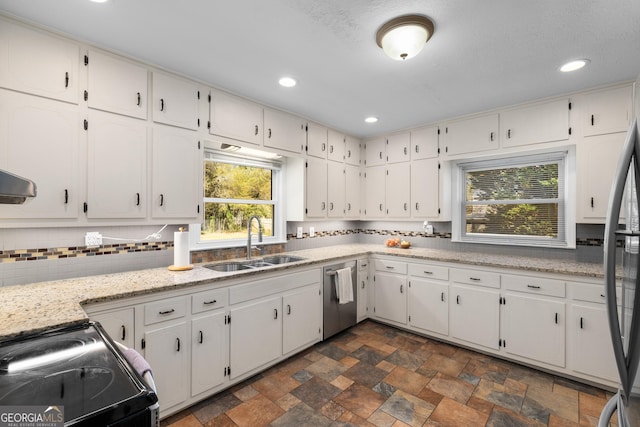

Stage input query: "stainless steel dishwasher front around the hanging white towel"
[{"left": 322, "top": 261, "right": 358, "bottom": 339}]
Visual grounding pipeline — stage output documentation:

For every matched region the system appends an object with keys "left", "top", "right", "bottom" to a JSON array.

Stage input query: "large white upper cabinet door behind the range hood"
[{"left": 0, "top": 89, "right": 79, "bottom": 219}]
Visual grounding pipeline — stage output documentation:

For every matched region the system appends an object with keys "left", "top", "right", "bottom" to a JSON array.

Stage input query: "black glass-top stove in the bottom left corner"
[{"left": 0, "top": 322, "right": 158, "bottom": 426}]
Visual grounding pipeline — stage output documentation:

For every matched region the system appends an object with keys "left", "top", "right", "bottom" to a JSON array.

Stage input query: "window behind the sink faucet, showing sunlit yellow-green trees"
[{"left": 192, "top": 150, "right": 285, "bottom": 249}]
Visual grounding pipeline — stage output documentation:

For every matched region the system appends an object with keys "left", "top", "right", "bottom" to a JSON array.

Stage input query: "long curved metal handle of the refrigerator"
[{"left": 604, "top": 119, "right": 640, "bottom": 402}]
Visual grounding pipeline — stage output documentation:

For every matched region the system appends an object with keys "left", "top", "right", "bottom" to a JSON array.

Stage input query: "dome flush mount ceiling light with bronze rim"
[{"left": 376, "top": 15, "right": 434, "bottom": 61}]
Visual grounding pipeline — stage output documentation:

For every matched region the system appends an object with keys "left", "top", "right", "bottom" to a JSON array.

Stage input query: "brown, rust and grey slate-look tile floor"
[{"left": 161, "top": 321, "right": 611, "bottom": 427}]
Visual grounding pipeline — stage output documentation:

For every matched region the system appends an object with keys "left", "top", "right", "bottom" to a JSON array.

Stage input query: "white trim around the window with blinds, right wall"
[{"left": 451, "top": 146, "right": 576, "bottom": 249}]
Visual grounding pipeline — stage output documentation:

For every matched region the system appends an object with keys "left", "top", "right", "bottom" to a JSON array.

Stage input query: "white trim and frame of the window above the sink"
[{"left": 189, "top": 148, "right": 286, "bottom": 251}]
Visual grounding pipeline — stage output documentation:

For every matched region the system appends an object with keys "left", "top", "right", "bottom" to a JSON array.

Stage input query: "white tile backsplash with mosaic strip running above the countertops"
[{"left": 0, "top": 221, "right": 604, "bottom": 286}]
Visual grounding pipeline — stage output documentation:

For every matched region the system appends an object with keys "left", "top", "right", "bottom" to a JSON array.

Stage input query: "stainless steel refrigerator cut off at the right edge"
[{"left": 594, "top": 76, "right": 640, "bottom": 427}]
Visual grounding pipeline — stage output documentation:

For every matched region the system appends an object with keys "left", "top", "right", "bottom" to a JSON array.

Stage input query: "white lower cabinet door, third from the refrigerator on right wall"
[{"left": 449, "top": 286, "right": 500, "bottom": 350}]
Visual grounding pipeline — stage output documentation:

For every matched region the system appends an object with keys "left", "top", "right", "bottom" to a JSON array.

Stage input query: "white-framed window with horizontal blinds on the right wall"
[{"left": 452, "top": 150, "right": 575, "bottom": 248}]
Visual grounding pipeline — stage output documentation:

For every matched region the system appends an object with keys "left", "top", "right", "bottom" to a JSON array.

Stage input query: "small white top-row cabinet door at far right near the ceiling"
[{"left": 582, "top": 85, "right": 640, "bottom": 136}]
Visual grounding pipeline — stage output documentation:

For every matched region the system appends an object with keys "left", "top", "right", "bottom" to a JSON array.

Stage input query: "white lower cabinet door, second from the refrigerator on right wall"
[{"left": 502, "top": 294, "right": 565, "bottom": 367}]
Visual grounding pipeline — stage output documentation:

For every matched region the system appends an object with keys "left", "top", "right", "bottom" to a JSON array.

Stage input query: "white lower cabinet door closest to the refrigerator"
[{"left": 570, "top": 305, "right": 619, "bottom": 382}]
